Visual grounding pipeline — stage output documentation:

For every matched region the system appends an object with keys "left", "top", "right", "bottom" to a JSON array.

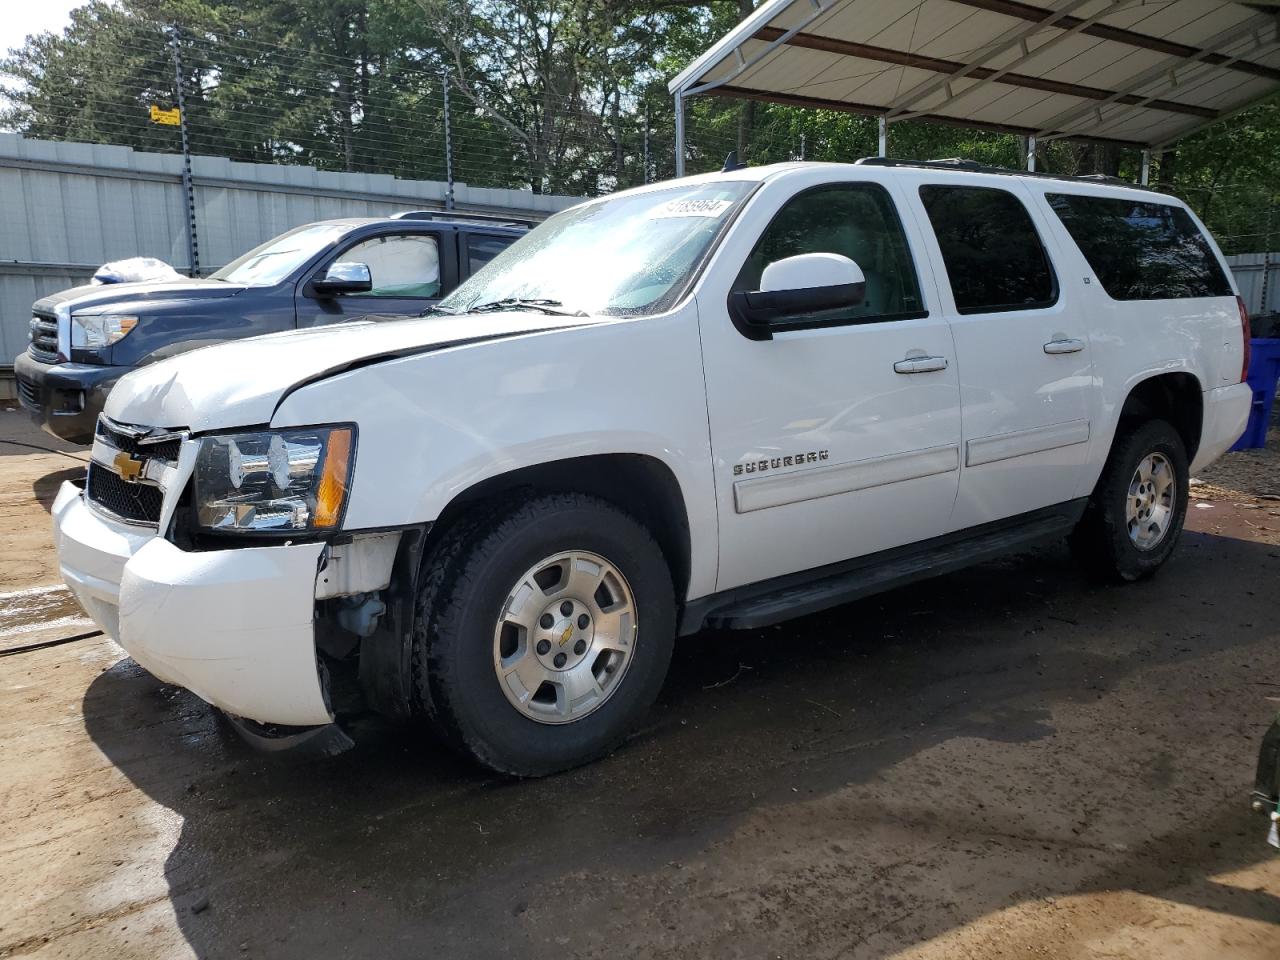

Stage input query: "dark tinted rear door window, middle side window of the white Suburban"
[{"left": 920, "top": 186, "right": 1057, "bottom": 314}]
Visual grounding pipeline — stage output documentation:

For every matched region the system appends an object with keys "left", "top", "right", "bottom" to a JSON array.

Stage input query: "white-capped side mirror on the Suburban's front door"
[{"left": 728, "top": 253, "right": 867, "bottom": 340}]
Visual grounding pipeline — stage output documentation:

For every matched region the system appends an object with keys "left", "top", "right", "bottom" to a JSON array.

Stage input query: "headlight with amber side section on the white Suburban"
[{"left": 196, "top": 426, "right": 356, "bottom": 532}]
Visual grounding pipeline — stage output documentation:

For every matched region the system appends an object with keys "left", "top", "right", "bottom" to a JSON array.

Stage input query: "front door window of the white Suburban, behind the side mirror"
[{"left": 733, "top": 183, "right": 927, "bottom": 323}]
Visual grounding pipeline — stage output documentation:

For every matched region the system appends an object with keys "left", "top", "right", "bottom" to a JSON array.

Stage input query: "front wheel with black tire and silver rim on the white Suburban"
[{"left": 412, "top": 493, "right": 676, "bottom": 777}]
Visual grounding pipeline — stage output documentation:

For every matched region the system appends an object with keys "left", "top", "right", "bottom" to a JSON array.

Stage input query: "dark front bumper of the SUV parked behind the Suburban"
[{"left": 13, "top": 353, "right": 132, "bottom": 444}]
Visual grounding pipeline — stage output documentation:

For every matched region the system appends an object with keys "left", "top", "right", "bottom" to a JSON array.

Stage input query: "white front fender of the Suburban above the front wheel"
[{"left": 271, "top": 312, "right": 717, "bottom": 598}]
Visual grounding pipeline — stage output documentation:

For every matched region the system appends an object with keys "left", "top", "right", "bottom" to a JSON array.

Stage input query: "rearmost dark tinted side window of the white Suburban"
[{"left": 1046, "top": 193, "right": 1231, "bottom": 300}]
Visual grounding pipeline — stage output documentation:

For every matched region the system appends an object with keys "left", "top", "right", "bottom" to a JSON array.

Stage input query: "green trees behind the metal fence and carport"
[{"left": 0, "top": 0, "right": 1280, "bottom": 252}]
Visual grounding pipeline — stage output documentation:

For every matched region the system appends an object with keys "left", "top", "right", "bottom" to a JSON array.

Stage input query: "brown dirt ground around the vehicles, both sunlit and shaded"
[{"left": 0, "top": 411, "right": 1280, "bottom": 960}]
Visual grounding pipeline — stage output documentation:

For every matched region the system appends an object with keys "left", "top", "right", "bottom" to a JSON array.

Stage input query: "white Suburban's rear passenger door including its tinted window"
[{"left": 915, "top": 177, "right": 1096, "bottom": 530}]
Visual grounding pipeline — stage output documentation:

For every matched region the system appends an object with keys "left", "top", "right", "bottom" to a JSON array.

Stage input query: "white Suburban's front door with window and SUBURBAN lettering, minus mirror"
[{"left": 690, "top": 170, "right": 960, "bottom": 590}]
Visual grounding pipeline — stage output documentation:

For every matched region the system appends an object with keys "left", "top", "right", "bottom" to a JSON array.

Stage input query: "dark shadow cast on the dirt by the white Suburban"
[{"left": 83, "top": 534, "right": 1280, "bottom": 957}]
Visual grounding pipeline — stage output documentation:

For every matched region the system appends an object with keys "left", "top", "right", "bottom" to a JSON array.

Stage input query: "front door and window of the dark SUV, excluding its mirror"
[{"left": 296, "top": 230, "right": 457, "bottom": 326}]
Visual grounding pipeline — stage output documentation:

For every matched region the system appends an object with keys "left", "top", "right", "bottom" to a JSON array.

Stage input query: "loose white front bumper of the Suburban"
[{"left": 52, "top": 484, "right": 333, "bottom": 726}]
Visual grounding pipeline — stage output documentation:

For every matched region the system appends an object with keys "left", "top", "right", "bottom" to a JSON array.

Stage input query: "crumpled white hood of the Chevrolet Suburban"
[{"left": 106, "top": 311, "right": 599, "bottom": 433}]
